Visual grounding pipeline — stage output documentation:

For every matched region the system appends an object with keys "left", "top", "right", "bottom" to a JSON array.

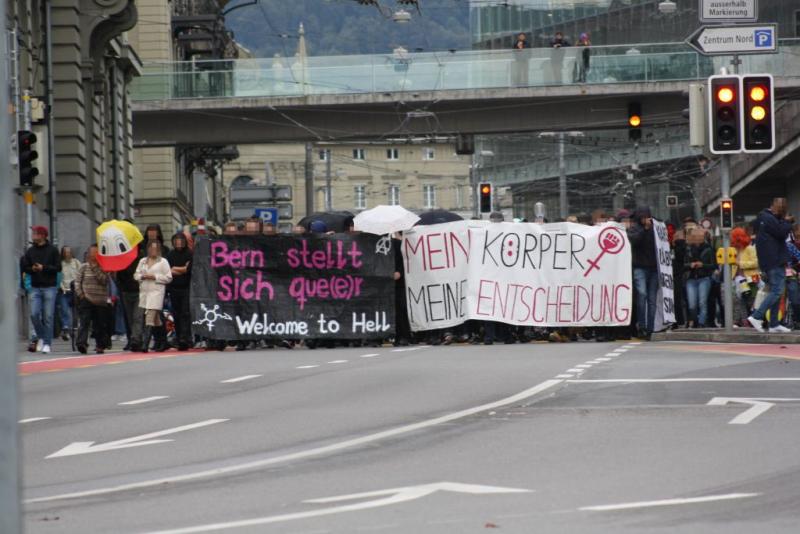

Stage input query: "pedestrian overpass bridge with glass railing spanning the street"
[{"left": 132, "top": 39, "right": 800, "bottom": 147}]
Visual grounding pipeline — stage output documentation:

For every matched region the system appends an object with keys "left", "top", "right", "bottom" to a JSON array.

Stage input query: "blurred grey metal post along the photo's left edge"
[{"left": 0, "top": 2, "right": 22, "bottom": 534}]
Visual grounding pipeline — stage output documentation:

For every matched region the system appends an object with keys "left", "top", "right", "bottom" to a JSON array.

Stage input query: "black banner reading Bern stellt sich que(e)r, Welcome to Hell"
[{"left": 191, "top": 234, "right": 395, "bottom": 340}]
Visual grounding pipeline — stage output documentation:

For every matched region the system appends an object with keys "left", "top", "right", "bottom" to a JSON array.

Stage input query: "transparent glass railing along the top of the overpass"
[{"left": 131, "top": 39, "right": 800, "bottom": 100}]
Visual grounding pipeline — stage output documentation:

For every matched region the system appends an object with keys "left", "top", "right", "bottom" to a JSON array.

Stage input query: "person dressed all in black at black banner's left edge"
[{"left": 166, "top": 232, "right": 192, "bottom": 350}]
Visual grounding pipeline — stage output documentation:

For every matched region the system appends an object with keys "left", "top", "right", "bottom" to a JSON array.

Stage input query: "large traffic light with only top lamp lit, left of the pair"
[{"left": 708, "top": 76, "right": 742, "bottom": 154}]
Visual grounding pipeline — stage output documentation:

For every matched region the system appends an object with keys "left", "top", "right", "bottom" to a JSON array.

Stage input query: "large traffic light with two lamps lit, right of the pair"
[{"left": 742, "top": 74, "right": 775, "bottom": 152}]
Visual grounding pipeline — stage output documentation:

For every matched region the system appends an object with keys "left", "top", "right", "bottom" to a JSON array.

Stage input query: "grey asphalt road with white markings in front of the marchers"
[{"left": 21, "top": 342, "right": 800, "bottom": 534}]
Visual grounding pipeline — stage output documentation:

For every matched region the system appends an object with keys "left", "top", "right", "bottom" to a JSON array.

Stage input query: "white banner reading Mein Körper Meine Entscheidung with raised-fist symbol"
[{"left": 403, "top": 221, "right": 632, "bottom": 330}]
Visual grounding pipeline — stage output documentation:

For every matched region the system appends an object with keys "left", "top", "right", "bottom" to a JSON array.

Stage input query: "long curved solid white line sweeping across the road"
[{"left": 24, "top": 379, "right": 564, "bottom": 504}]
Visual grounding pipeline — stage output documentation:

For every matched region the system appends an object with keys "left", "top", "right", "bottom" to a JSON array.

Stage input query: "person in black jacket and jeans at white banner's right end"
[{"left": 628, "top": 206, "right": 658, "bottom": 339}]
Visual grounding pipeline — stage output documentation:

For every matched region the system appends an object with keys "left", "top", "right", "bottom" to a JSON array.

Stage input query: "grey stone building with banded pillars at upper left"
[{"left": 4, "top": 0, "right": 141, "bottom": 256}]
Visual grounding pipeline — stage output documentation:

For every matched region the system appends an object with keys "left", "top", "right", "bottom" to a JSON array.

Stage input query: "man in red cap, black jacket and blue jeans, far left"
[{"left": 20, "top": 226, "right": 61, "bottom": 354}]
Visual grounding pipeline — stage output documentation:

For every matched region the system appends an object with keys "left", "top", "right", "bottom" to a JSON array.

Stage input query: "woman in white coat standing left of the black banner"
[{"left": 133, "top": 241, "right": 172, "bottom": 352}]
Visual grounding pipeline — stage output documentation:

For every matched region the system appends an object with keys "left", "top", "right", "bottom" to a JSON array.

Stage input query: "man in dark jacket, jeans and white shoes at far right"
[{"left": 747, "top": 197, "right": 794, "bottom": 333}]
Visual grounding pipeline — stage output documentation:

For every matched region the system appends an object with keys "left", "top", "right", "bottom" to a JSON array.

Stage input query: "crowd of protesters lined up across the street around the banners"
[{"left": 20, "top": 198, "right": 800, "bottom": 354}]
